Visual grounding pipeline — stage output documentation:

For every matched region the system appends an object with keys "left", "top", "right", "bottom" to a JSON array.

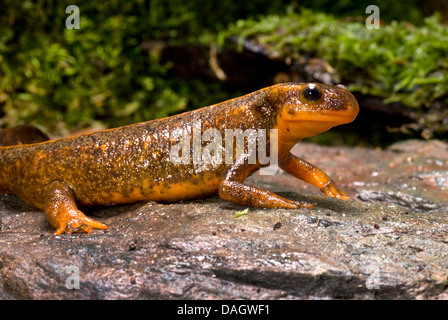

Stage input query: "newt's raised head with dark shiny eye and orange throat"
[{"left": 269, "top": 83, "right": 359, "bottom": 143}]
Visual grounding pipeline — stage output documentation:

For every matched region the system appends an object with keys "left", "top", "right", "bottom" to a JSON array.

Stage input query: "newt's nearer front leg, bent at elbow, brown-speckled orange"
[{"left": 219, "top": 157, "right": 314, "bottom": 209}]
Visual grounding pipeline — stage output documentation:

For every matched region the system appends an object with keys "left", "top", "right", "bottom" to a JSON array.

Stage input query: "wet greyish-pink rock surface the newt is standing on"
[{"left": 0, "top": 141, "right": 448, "bottom": 299}]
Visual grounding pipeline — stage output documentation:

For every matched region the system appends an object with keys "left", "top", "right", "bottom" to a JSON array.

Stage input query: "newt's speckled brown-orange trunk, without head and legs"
[{"left": 0, "top": 86, "right": 272, "bottom": 208}]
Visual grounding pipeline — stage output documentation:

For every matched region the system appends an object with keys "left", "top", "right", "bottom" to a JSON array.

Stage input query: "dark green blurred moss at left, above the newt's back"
[{"left": 0, "top": 0, "right": 300, "bottom": 135}]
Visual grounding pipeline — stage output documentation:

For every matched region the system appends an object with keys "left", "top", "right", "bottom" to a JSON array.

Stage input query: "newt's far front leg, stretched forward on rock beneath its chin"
[{"left": 279, "top": 153, "right": 350, "bottom": 199}]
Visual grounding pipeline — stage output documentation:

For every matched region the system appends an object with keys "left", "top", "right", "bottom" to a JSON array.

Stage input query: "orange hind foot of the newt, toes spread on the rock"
[{"left": 54, "top": 210, "right": 107, "bottom": 236}]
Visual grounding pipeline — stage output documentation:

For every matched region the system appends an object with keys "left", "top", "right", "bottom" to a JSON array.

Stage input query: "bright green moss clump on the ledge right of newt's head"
[{"left": 218, "top": 9, "right": 448, "bottom": 131}]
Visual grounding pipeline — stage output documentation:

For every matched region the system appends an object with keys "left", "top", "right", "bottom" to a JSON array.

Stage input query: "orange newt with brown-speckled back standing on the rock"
[{"left": 0, "top": 83, "right": 359, "bottom": 235}]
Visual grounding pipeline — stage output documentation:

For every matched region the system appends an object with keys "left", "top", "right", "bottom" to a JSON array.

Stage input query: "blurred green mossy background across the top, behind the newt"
[{"left": 0, "top": 0, "right": 448, "bottom": 145}]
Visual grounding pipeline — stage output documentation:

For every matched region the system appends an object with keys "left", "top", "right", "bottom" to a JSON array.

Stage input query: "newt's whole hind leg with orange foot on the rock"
[{"left": 44, "top": 181, "right": 107, "bottom": 235}]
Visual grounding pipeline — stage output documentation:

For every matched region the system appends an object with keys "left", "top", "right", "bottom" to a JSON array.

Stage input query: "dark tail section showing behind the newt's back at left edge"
[{"left": 0, "top": 125, "right": 50, "bottom": 147}]
